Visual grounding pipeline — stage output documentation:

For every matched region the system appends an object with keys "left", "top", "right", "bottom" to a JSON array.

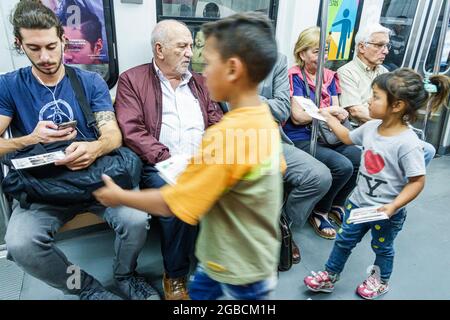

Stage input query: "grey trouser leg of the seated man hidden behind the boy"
[{"left": 283, "top": 143, "right": 332, "bottom": 227}]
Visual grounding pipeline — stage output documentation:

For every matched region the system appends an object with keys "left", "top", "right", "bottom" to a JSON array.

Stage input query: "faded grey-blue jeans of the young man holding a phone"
[{"left": 5, "top": 201, "right": 149, "bottom": 295}]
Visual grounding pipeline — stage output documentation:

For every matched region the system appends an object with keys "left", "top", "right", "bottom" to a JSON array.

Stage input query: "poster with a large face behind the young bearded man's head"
[{"left": 41, "top": 0, "right": 118, "bottom": 88}]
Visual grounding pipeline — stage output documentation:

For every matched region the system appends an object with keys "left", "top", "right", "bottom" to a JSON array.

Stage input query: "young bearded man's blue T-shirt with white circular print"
[{"left": 0, "top": 67, "right": 114, "bottom": 139}]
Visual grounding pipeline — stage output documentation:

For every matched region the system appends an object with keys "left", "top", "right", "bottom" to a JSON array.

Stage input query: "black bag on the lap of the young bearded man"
[{"left": 2, "top": 141, "right": 142, "bottom": 208}]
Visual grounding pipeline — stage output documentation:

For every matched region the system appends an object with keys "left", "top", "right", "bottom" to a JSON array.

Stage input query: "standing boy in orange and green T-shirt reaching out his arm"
[{"left": 95, "top": 13, "right": 285, "bottom": 300}]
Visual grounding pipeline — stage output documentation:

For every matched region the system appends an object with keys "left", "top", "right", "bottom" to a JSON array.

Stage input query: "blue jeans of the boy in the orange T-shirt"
[{"left": 189, "top": 264, "right": 278, "bottom": 300}]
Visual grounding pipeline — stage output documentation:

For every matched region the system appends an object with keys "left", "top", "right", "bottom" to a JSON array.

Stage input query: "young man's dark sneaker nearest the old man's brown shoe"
[{"left": 116, "top": 276, "right": 161, "bottom": 300}]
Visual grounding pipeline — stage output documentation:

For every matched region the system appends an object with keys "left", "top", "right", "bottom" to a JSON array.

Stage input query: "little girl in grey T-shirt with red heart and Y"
[{"left": 304, "top": 68, "right": 450, "bottom": 299}]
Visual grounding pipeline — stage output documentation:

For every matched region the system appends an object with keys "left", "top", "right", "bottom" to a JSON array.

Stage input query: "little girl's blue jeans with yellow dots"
[{"left": 325, "top": 202, "right": 406, "bottom": 282}]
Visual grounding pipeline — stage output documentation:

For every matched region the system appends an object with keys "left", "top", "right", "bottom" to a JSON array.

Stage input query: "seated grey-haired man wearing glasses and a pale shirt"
[{"left": 338, "top": 23, "right": 436, "bottom": 165}]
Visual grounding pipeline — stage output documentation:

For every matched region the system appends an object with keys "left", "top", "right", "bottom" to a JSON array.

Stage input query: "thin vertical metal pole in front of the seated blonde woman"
[{"left": 310, "top": 0, "right": 329, "bottom": 157}]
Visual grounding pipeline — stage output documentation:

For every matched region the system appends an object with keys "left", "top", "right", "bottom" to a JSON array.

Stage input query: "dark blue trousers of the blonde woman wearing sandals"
[{"left": 294, "top": 141, "right": 361, "bottom": 213}]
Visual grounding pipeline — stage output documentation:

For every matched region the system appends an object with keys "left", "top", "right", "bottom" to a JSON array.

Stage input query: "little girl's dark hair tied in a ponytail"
[{"left": 373, "top": 68, "right": 450, "bottom": 121}]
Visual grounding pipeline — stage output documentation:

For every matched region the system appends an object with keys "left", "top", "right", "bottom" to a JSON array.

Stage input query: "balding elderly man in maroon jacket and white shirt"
[{"left": 115, "top": 20, "right": 223, "bottom": 300}]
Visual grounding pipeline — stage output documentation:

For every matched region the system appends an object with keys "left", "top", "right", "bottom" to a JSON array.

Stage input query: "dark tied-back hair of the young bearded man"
[{"left": 10, "top": 0, "right": 64, "bottom": 52}]
